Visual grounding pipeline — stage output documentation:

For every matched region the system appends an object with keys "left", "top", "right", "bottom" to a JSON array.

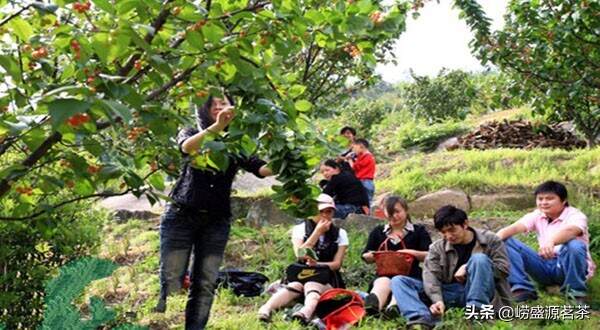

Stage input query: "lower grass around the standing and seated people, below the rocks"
[{"left": 80, "top": 206, "right": 600, "bottom": 330}]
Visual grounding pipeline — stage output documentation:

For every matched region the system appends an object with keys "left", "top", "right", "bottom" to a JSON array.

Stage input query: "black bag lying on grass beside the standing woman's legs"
[{"left": 217, "top": 270, "right": 269, "bottom": 297}]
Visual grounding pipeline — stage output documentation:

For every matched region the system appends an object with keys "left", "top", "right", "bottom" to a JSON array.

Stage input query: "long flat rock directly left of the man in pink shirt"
[{"left": 471, "top": 193, "right": 535, "bottom": 211}]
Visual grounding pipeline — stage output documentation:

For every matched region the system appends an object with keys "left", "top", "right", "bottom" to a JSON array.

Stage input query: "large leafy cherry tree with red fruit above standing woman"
[{"left": 0, "top": 0, "right": 409, "bottom": 224}]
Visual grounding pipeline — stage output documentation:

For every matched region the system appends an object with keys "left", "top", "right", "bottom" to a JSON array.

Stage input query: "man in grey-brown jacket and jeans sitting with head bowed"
[{"left": 392, "top": 205, "right": 510, "bottom": 328}]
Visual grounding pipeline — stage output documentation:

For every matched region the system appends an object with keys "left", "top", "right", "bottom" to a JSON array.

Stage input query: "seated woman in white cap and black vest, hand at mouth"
[{"left": 258, "top": 194, "right": 349, "bottom": 323}]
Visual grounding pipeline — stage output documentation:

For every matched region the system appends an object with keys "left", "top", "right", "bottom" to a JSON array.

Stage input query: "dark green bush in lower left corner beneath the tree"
[{"left": 0, "top": 203, "right": 106, "bottom": 329}]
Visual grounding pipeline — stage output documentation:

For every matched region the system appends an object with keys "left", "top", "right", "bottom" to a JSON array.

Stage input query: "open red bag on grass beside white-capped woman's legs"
[{"left": 315, "top": 289, "right": 366, "bottom": 330}]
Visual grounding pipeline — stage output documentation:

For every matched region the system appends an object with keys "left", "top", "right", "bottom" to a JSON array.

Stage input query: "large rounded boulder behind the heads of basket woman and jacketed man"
[{"left": 408, "top": 189, "right": 471, "bottom": 218}]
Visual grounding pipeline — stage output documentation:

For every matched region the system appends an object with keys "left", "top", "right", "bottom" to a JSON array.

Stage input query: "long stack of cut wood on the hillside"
[{"left": 452, "top": 119, "right": 586, "bottom": 150}]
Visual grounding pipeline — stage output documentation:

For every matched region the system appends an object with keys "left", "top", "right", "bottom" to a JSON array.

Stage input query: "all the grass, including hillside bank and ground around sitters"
[{"left": 81, "top": 148, "right": 600, "bottom": 329}]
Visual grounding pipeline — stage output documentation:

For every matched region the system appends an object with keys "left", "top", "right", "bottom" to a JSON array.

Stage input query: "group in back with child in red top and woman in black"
[{"left": 320, "top": 126, "right": 376, "bottom": 219}]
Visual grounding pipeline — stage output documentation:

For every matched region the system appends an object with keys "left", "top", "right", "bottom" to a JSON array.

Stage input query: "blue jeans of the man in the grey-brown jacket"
[{"left": 392, "top": 253, "right": 495, "bottom": 325}]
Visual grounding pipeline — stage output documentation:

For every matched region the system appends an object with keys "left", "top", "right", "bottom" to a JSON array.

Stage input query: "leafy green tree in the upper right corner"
[{"left": 456, "top": 0, "right": 600, "bottom": 147}]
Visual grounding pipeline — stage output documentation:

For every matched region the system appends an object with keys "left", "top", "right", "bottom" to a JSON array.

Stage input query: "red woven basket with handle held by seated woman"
[{"left": 373, "top": 237, "right": 415, "bottom": 277}]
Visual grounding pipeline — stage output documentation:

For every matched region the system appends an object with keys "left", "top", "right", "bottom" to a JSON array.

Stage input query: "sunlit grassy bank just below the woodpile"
[{"left": 376, "top": 148, "right": 600, "bottom": 199}]
